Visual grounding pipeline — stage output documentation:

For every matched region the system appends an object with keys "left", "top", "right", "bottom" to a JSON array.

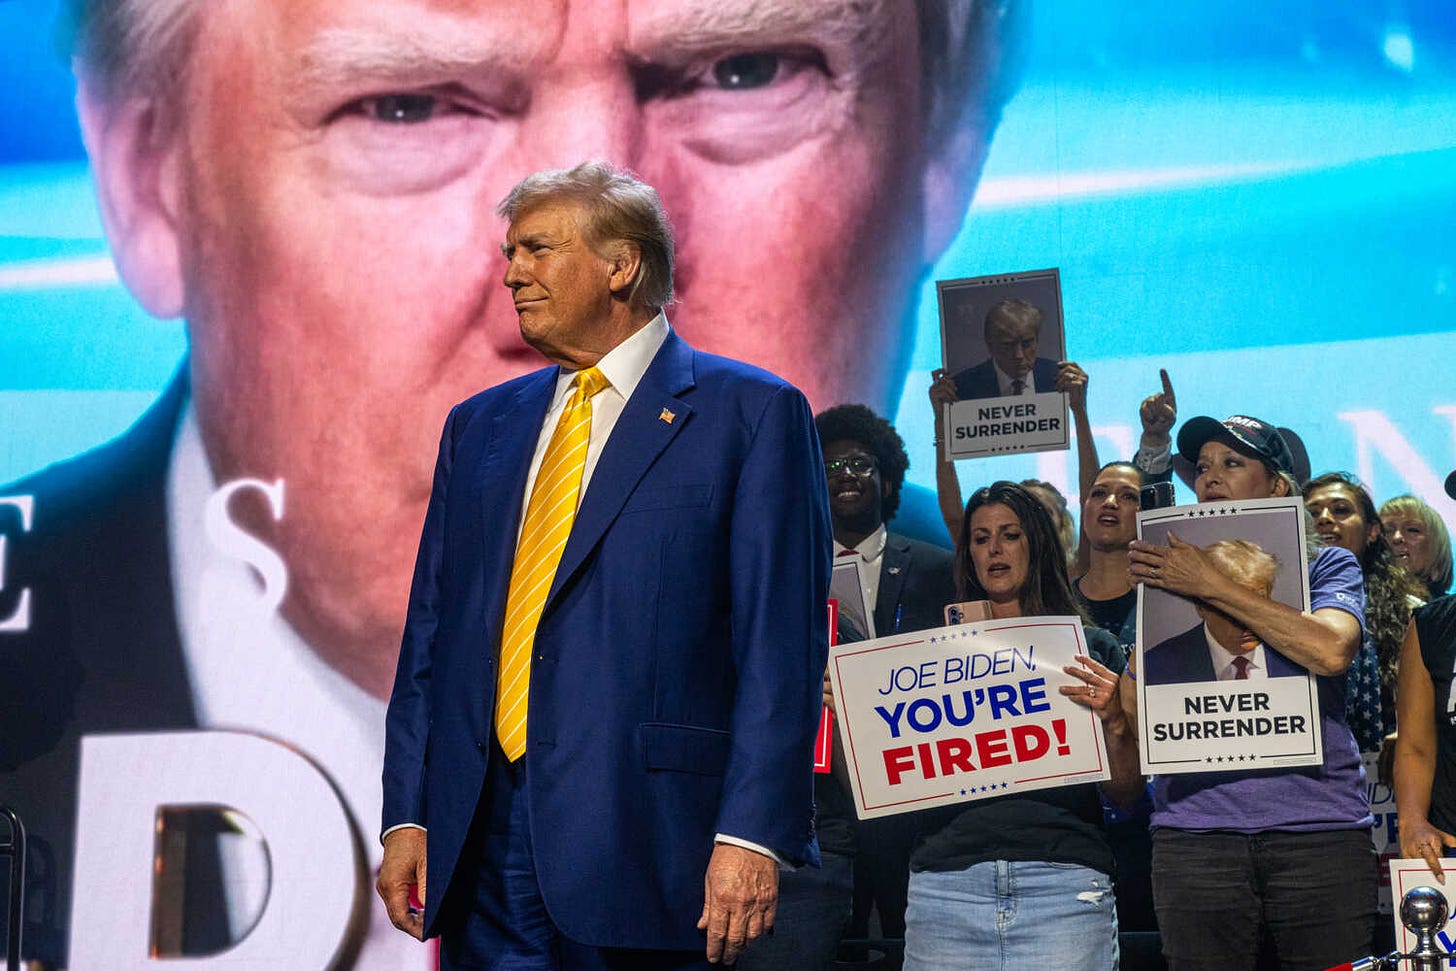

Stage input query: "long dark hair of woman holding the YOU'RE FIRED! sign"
[{"left": 955, "top": 479, "right": 1092, "bottom": 623}]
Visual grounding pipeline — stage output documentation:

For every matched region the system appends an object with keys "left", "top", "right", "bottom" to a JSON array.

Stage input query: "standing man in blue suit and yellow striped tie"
[{"left": 379, "top": 163, "right": 830, "bottom": 968}]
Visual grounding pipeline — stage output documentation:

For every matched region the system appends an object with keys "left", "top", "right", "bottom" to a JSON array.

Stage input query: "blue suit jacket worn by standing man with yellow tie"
[{"left": 383, "top": 335, "right": 831, "bottom": 949}]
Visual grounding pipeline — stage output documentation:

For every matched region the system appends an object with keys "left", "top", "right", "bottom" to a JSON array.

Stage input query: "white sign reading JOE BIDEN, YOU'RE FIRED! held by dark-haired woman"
[{"left": 830, "top": 617, "right": 1109, "bottom": 820}]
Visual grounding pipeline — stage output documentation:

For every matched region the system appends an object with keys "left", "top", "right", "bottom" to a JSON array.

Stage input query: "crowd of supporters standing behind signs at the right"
[{"left": 786, "top": 361, "right": 1456, "bottom": 971}]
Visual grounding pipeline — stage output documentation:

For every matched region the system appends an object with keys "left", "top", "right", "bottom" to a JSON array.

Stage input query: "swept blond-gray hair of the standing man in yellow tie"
[{"left": 495, "top": 162, "right": 673, "bottom": 310}]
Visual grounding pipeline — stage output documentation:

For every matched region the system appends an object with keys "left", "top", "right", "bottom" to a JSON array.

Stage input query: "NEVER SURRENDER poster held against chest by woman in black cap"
[{"left": 1137, "top": 499, "right": 1324, "bottom": 773}]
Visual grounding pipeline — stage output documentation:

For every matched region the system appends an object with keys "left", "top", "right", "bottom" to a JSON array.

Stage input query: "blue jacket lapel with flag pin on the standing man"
[{"left": 546, "top": 333, "right": 693, "bottom": 610}]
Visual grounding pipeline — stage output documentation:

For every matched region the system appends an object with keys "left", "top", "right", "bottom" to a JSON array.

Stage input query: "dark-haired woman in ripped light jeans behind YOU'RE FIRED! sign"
[{"left": 904, "top": 482, "right": 1143, "bottom": 971}]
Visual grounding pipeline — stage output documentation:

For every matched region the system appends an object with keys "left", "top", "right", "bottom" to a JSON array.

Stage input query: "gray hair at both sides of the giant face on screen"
[{"left": 66, "top": 0, "right": 1029, "bottom": 147}]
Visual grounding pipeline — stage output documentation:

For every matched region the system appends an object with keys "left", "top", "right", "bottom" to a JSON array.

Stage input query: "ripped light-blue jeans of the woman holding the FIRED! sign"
[{"left": 904, "top": 860, "right": 1118, "bottom": 971}]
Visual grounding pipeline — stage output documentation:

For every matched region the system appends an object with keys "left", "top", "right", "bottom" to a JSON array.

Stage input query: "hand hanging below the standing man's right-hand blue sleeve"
[{"left": 697, "top": 843, "right": 779, "bottom": 964}]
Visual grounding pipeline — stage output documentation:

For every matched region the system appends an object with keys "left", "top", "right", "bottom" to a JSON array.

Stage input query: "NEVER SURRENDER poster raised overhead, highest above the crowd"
[{"left": 936, "top": 269, "right": 1069, "bottom": 459}]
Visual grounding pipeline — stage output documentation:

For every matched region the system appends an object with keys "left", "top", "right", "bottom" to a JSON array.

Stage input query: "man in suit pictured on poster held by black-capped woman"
[{"left": 1143, "top": 540, "right": 1309, "bottom": 684}]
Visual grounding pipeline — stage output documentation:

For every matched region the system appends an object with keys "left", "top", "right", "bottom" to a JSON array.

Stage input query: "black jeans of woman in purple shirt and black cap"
[{"left": 1153, "top": 828, "right": 1377, "bottom": 971}]
